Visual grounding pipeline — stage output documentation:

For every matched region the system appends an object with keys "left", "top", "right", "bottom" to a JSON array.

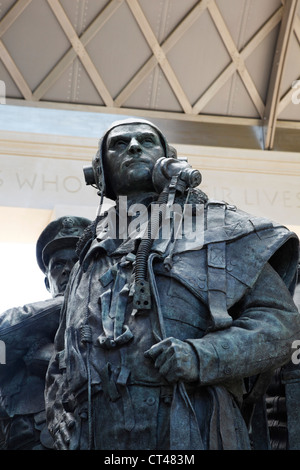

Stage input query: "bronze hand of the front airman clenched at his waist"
[{"left": 144, "top": 337, "right": 199, "bottom": 383}]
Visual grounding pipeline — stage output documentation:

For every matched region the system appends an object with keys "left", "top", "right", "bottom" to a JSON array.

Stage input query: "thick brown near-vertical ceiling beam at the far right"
[{"left": 263, "top": 0, "right": 298, "bottom": 150}]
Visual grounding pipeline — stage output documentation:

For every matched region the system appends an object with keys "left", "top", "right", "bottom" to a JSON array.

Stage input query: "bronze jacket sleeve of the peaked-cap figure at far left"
[{"left": 0, "top": 296, "right": 63, "bottom": 364}]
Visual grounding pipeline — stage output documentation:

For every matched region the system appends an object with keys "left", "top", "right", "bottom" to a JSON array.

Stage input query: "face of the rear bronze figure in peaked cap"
[{"left": 45, "top": 248, "right": 78, "bottom": 297}]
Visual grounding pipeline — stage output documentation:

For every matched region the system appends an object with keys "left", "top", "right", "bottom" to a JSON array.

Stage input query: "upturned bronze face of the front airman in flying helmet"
[{"left": 104, "top": 124, "right": 165, "bottom": 196}]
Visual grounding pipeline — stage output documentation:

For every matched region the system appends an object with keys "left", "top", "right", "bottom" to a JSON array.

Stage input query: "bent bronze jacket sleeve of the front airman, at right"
[{"left": 187, "top": 264, "right": 300, "bottom": 385}]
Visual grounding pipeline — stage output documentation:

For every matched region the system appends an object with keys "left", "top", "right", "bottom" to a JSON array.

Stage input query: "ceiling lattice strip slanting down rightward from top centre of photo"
[{"left": 127, "top": 0, "right": 192, "bottom": 113}]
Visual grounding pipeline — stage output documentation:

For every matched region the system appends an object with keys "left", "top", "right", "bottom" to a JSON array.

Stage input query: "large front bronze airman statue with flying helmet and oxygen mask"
[{"left": 46, "top": 120, "right": 300, "bottom": 450}]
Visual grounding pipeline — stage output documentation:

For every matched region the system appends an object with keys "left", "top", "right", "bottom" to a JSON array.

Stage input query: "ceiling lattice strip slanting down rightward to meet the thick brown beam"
[{"left": 208, "top": 0, "right": 265, "bottom": 117}]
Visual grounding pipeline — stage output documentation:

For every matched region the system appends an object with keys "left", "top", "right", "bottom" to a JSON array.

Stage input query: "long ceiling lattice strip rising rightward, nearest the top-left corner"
[{"left": 33, "top": 0, "right": 124, "bottom": 101}]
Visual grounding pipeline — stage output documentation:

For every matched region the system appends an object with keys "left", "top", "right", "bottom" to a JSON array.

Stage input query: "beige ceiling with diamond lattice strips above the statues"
[{"left": 0, "top": 0, "right": 300, "bottom": 149}]
